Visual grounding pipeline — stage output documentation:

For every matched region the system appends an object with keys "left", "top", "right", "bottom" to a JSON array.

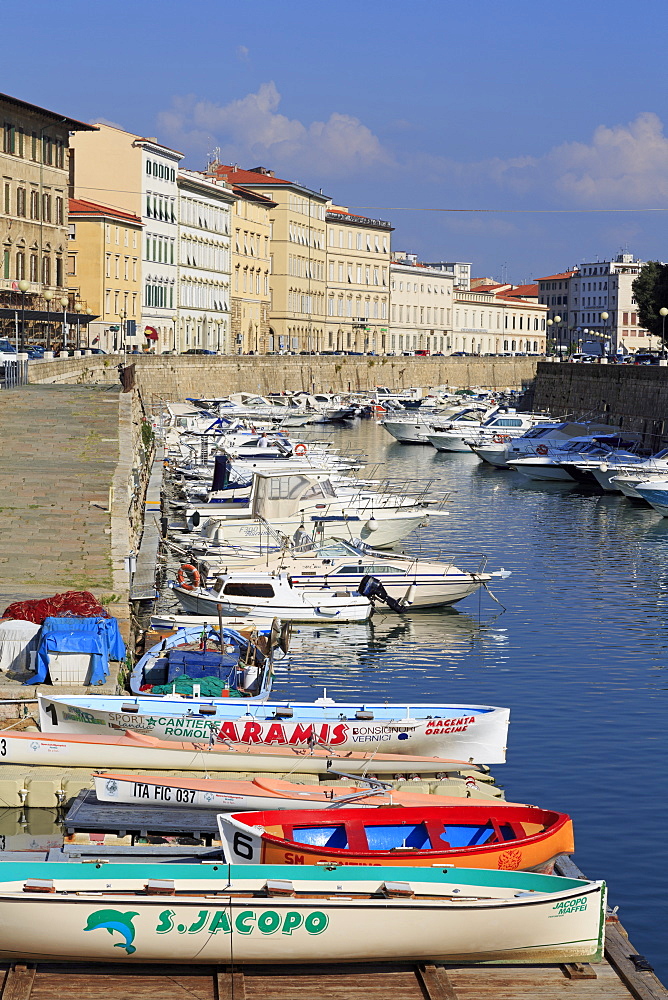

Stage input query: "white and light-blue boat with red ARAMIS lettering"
[{"left": 38, "top": 691, "right": 510, "bottom": 764}]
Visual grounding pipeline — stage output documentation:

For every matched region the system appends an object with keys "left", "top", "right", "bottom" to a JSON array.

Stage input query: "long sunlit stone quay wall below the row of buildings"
[{"left": 30, "top": 354, "right": 537, "bottom": 402}]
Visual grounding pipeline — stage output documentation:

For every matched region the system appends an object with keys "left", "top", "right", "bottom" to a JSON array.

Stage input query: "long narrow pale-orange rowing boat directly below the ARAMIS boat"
[{"left": 0, "top": 730, "right": 482, "bottom": 775}]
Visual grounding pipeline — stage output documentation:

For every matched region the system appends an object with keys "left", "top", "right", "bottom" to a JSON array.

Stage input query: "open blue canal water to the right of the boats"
[{"left": 275, "top": 421, "right": 668, "bottom": 982}]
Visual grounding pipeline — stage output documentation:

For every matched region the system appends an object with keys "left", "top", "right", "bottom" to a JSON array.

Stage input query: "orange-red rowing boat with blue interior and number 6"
[{"left": 218, "top": 801, "right": 575, "bottom": 874}]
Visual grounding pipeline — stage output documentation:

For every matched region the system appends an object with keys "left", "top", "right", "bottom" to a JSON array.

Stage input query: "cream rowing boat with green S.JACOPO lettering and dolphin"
[{"left": 0, "top": 862, "right": 605, "bottom": 965}]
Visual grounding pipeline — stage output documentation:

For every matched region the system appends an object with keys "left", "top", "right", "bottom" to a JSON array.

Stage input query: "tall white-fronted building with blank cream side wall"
[{"left": 72, "top": 124, "right": 183, "bottom": 353}]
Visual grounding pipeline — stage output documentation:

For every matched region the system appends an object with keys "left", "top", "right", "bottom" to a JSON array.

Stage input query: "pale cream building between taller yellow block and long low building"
[{"left": 389, "top": 252, "right": 455, "bottom": 354}]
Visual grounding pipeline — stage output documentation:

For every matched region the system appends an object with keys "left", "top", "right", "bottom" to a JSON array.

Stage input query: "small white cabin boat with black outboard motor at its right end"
[{"left": 173, "top": 573, "right": 373, "bottom": 622}]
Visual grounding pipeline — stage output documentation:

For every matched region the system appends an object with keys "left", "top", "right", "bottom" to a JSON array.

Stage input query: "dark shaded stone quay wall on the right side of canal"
[{"left": 532, "top": 362, "right": 668, "bottom": 451}]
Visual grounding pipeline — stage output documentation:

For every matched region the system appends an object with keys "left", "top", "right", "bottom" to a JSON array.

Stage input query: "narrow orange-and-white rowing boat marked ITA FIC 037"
[{"left": 93, "top": 772, "right": 506, "bottom": 812}]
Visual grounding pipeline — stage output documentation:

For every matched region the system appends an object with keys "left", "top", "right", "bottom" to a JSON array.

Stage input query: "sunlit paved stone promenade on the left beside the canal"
[{"left": 0, "top": 385, "right": 120, "bottom": 613}]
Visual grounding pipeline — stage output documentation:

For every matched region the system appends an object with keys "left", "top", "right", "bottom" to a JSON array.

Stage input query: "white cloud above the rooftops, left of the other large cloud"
[{"left": 158, "top": 82, "right": 392, "bottom": 178}]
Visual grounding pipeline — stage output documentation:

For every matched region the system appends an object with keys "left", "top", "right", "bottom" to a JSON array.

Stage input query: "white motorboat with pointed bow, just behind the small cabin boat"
[{"left": 197, "top": 539, "right": 509, "bottom": 610}]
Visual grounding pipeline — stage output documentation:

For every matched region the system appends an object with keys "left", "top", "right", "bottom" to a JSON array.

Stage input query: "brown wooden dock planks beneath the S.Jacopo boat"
[{"left": 0, "top": 956, "right": 668, "bottom": 1000}]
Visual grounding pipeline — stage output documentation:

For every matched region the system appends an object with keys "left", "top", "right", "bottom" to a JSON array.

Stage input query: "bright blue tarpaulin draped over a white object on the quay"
[{"left": 25, "top": 618, "right": 125, "bottom": 684}]
